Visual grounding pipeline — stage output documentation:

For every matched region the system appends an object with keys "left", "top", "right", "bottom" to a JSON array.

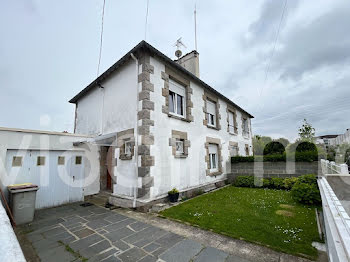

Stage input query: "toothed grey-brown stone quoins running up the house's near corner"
[{"left": 137, "top": 54, "right": 155, "bottom": 198}]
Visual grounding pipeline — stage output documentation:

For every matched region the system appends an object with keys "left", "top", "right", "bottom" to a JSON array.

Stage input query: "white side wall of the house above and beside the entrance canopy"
[{"left": 76, "top": 59, "right": 138, "bottom": 196}]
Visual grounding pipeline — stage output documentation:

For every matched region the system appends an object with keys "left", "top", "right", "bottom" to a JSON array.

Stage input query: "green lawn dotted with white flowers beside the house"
[{"left": 161, "top": 186, "right": 320, "bottom": 259}]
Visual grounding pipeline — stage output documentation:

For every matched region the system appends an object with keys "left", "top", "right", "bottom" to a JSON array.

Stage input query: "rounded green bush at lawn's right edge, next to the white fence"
[{"left": 290, "top": 180, "right": 321, "bottom": 205}]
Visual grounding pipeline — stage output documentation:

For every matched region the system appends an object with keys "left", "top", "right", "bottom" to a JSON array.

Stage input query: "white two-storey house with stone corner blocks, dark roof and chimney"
[{"left": 69, "top": 41, "right": 253, "bottom": 206}]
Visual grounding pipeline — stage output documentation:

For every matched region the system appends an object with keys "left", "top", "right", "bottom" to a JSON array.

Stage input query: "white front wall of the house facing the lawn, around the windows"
[{"left": 151, "top": 57, "right": 252, "bottom": 198}]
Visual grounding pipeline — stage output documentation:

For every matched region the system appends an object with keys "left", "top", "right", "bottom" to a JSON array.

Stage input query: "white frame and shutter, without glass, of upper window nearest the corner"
[{"left": 169, "top": 79, "right": 186, "bottom": 118}]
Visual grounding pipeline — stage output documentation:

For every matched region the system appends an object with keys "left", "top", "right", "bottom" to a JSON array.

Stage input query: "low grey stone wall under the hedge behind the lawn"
[{"left": 228, "top": 162, "right": 321, "bottom": 182}]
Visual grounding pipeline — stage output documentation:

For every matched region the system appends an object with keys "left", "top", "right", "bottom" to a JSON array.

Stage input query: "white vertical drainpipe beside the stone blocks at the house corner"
[{"left": 130, "top": 53, "right": 139, "bottom": 208}]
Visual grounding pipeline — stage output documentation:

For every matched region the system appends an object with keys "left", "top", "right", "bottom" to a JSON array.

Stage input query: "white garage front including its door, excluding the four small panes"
[{"left": 0, "top": 128, "right": 100, "bottom": 208}]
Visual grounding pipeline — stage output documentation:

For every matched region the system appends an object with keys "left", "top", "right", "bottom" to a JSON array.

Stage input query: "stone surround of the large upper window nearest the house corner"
[{"left": 161, "top": 67, "right": 193, "bottom": 122}]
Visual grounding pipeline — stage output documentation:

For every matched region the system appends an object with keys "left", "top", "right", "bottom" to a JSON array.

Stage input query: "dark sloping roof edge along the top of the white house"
[{"left": 69, "top": 41, "right": 254, "bottom": 118}]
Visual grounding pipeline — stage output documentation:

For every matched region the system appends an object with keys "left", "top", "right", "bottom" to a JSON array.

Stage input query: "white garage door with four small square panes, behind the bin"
[{"left": 6, "top": 150, "right": 84, "bottom": 208}]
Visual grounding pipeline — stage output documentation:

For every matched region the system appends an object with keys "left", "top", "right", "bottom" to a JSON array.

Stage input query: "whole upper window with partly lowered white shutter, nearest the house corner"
[{"left": 169, "top": 80, "right": 186, "bottom": 117}]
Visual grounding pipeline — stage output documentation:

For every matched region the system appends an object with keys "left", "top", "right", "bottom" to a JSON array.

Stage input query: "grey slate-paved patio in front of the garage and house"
[{"left": 22, "top": 203, "right": 249, "bottom": 262}]
